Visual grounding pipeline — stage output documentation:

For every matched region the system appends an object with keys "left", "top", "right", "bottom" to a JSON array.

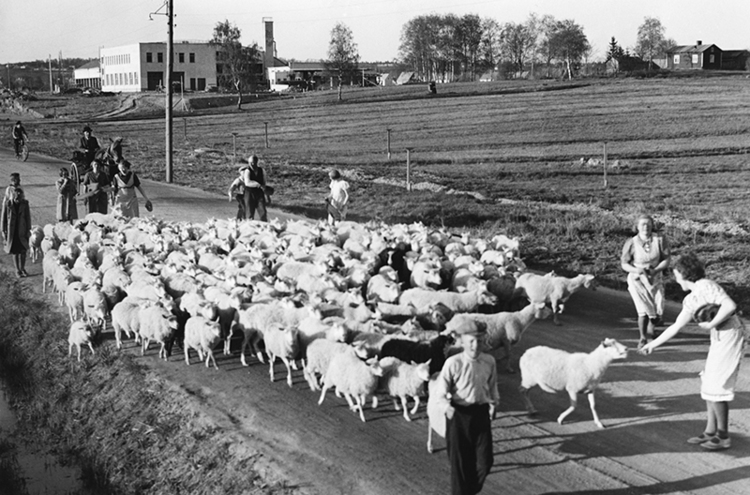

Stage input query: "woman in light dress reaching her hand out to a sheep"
[{"left": 641, "top": 253, "right": 745, "bottom": 450}]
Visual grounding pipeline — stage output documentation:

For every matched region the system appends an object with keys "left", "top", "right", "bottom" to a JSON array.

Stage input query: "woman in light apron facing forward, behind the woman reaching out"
[{"left": 620, "top": 215, "right": 670, "bottom": 348}]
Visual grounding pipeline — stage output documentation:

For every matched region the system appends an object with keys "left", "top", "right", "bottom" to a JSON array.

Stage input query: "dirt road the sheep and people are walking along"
[{"left": 0, "top": 150, "right": 750, "bottom": 495}]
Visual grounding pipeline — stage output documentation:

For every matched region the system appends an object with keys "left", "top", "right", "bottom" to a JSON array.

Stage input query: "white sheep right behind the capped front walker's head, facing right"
[{"left": 446, "top": 303, "right": 552, "bottom": 373}]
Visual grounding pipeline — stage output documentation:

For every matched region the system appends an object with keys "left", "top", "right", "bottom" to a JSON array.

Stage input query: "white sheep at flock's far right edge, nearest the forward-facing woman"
[{"left": 516, "top": 273, "right": 594, "bottom": 325}]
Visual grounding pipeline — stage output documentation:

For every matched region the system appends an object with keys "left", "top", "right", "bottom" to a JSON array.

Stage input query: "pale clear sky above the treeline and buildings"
[{"left": 0, "top": 0, "right": 750, "bottom": 64}]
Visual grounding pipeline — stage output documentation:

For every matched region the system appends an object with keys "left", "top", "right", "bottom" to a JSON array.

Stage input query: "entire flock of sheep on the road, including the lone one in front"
[{"left": 30, "top": 214, "right": 626, "bottom": 452}]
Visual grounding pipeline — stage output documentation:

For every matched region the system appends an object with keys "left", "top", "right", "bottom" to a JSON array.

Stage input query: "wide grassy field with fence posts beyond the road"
[{"left": 17, "top": 76, "right": 750, "bottom": 307}]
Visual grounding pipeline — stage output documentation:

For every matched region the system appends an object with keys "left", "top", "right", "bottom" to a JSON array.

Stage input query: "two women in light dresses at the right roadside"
[{"left": 620, "top": 215, "right": 745, "bottom": 450}]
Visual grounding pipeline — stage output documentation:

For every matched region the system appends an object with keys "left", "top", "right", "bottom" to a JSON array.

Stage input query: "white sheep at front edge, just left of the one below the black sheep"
[{"left": 318, "top": 351, "right": 383, "bottom": 423}]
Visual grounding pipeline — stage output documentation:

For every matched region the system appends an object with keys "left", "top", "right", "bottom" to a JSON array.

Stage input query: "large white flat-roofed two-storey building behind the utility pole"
[{"left": 99, "top": 41, "right": 216, "bottom": 93}]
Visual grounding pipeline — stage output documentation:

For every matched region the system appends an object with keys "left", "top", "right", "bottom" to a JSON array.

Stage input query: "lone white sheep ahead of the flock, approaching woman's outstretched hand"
[{"left": 519, "top": 339, "right": 628, "bottom": 428}]
